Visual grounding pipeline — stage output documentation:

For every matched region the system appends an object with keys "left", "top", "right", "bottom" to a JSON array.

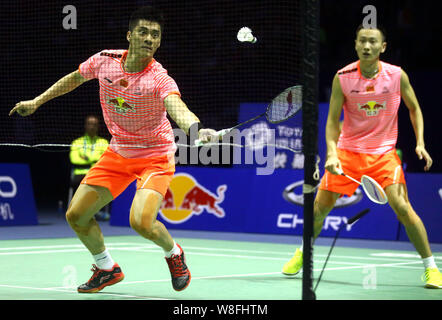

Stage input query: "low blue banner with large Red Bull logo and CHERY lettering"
[{"left": 110, "top": 167, "right": 408, "bottom": 240}]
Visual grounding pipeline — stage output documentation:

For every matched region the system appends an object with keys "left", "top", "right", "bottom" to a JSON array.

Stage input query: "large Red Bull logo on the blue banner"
[{"left": 160, "top": 173, "right": 227, "bottom": 224}]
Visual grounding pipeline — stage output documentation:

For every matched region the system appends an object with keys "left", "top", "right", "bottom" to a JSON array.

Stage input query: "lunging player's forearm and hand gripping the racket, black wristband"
[{"left": 164, "top": 94, "right": 216, "bottom": 142}]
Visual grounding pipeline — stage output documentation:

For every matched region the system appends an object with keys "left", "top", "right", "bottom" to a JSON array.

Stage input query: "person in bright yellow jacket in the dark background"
[{"left": 69, "top": 115, "right": 110, "bottom": 221}]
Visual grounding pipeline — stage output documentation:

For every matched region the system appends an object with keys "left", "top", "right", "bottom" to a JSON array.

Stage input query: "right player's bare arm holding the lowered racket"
[{"left": 325, "top": 74, "right": 345, "bottom": 174}]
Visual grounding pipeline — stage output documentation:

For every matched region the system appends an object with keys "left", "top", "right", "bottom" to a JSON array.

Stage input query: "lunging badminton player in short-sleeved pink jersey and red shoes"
[{"left": 10, "top": 7, "right": 216, "bottom": 293}]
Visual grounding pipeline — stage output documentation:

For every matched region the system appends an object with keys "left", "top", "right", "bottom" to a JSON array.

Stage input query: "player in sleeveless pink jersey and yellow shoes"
[{"left": 282, "top": 26, "right": 442, "bottom": 288}]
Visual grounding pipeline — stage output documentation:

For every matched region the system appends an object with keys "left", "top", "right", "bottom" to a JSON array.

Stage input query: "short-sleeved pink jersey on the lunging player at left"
[{"left": 79, "top": 50, "right": 180, "bottom": 158}]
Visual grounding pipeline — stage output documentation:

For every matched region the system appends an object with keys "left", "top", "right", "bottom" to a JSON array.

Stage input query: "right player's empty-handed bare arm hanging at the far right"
[{"left": 401, "top": 70, "right": 433, "bottom": 171}]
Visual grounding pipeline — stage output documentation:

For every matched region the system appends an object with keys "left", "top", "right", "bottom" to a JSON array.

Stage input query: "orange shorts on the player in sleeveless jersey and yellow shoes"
[{"left": 319, "top": 149, "right": 405, "bottom": 196}]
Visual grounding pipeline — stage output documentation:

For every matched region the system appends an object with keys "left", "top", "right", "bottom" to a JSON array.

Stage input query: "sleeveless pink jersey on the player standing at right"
[{"left": 338, "top": 61, "right": 401, "bottom": 154}]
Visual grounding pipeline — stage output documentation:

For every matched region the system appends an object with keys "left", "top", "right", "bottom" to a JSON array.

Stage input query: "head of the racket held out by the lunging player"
[{"left": 266, "top": 86, "right": 302, "bottom": 123}]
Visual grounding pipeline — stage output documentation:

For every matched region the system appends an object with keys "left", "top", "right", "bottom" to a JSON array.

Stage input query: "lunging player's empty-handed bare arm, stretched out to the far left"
[{"left": 9, "top": 70, "right": 88, "bottom": 117}]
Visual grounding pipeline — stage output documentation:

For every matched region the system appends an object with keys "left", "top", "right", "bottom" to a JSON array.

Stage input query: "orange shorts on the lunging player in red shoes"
[{"left": 81, "top": 147, "right": 175, "bottom": 199}]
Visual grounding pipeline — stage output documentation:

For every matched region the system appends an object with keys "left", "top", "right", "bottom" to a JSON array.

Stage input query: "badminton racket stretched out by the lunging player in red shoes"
[{"left": 195, "top": 86, "right": 302, "bottom": 146}]
